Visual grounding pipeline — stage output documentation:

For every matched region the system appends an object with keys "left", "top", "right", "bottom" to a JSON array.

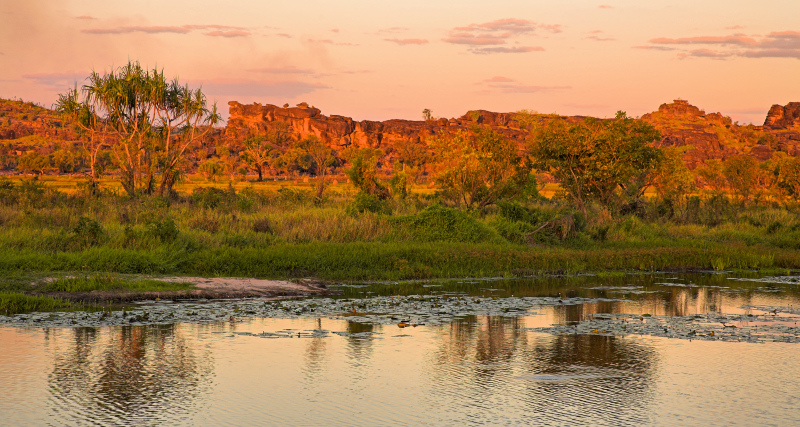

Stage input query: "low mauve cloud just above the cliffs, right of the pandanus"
[{"left": 203, "top": 79, "right": 330, "bottom": 98}]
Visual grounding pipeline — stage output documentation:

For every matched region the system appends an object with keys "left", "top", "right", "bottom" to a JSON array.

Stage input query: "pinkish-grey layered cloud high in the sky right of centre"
[{"left": 442, "top": 18, "right": 561, "bottom": 54}]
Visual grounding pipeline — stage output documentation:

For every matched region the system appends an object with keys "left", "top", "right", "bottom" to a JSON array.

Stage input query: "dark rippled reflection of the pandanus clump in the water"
[{"left": 48, "top": 325, "right": 213, "bottom": 424}]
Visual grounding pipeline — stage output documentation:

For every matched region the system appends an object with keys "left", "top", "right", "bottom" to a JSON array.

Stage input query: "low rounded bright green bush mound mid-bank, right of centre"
[{"left": 390, "top": 205, "right": 501, "bottom": 243}]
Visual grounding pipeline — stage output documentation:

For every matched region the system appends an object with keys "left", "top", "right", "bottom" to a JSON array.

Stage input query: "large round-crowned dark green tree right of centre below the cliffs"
[{"left": 531, "top": 112, "right": 663, "bottom": 216}]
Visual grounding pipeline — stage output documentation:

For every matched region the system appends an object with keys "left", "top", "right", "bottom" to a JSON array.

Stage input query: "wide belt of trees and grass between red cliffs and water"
[{"left": 0, "top": 65, "right": 800, "bottom": 316}]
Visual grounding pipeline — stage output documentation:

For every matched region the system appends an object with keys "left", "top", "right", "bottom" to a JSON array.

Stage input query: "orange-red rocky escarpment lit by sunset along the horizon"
[{"left": 0, "top": 99, "right": 800, "bottom": 173}]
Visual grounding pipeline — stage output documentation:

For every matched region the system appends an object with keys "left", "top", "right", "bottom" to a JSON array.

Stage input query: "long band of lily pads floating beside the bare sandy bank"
[{"left": 0, "top": 293, "right": 621, "bottom": 330}]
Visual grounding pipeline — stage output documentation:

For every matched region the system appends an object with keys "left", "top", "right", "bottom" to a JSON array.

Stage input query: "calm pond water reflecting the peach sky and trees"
[{"left": 0, "top": 274, "right": 800, "bottom": 426}]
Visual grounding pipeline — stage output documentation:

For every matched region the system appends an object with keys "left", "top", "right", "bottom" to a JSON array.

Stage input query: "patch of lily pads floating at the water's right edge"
[{"left": 525, "top": 306, "right": 800, "bottom": 343}]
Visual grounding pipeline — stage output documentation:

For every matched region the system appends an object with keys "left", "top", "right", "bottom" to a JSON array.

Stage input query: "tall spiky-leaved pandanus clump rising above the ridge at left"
[{"left": 59, "top": 61, "right": 220, "bottom": 197}]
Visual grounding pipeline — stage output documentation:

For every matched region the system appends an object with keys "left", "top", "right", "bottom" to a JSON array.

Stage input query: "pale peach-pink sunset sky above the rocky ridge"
[{"left": 0, "top": 0, "right": 800, "bottom": 125}]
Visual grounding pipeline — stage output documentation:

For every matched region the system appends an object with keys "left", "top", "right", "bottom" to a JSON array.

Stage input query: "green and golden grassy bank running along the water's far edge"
[{"left": 0, "top": 177, "right": 800, "bottom": 286}]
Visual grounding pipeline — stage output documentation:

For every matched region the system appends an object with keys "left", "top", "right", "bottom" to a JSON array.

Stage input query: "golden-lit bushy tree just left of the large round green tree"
[{"left": 430, "top": 127, "right": 536, "bottom": 209}]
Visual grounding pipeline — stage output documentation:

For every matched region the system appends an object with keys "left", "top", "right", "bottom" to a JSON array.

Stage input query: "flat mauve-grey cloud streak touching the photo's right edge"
[{"left": 648, "top": 31, "right": 800, "bottom": 59}]
